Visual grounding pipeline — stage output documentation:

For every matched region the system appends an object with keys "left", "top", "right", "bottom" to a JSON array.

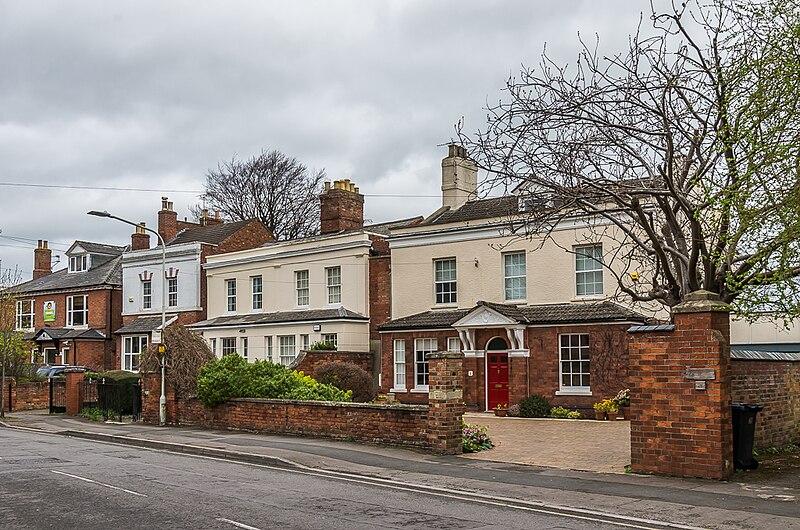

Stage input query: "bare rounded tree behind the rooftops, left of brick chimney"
[{"left": 197, "top": 150, "right": 325, "bottom": 239}]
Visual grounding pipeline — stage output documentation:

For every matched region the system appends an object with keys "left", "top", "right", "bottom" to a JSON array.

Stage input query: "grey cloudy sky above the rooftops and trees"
[{"left": 0, "top": 0, "right": 649, "bottom": 279}]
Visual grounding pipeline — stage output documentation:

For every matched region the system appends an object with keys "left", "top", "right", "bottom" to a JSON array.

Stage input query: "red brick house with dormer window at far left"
[{"left": 15, "top": 240, "right": 126, "bottom": 370}]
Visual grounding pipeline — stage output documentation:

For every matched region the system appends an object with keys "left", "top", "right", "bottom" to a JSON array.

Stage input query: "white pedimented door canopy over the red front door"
[{"left": 453, "top": 301, "right": 530, "bottom": 357}]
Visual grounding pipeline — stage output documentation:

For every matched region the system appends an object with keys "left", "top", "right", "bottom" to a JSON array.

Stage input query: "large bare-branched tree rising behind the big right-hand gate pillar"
[{"left": 457, "top": 0, "right": 800, "bottom": 318}]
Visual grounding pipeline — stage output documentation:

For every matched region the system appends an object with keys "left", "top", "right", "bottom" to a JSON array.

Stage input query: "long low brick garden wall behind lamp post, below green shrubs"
[{"left": 142, "top": 374, "right": 434, "bottom": 448}]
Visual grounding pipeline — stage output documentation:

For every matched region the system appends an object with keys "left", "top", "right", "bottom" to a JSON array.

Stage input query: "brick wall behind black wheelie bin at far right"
[{"left": 731, "top": 359, "right": 800, "bottom": 449}]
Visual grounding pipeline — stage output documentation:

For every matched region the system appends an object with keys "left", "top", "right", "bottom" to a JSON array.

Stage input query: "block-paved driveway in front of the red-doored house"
[{"left": 464, "top": 413, "right": 631, "bottom": 473}]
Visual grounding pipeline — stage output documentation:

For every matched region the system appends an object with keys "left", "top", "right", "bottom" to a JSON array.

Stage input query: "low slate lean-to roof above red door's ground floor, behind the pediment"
[{"left": 378, "top": 302, "right": 647, "bottom": 331}]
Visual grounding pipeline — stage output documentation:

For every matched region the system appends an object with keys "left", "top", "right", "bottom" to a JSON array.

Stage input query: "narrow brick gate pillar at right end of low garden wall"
[{"left": 427, "top": 352, "right": 464, "bottom": 455}]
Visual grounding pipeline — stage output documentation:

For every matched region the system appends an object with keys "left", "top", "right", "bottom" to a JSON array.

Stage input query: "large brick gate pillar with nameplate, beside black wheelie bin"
[{"left": 629, "top": 291, "right": 733, "bottom": 480}]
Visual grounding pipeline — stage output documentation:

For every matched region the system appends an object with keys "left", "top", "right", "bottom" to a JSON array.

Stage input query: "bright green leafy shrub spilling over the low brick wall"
[{"left": 197, "top": 353, "right": 353, "bottom": 407}]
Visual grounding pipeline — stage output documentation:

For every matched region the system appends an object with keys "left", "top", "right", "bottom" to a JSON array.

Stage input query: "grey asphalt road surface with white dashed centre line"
[{"left": 0, "top": 428, "right": 664, "bottom": 530}]
